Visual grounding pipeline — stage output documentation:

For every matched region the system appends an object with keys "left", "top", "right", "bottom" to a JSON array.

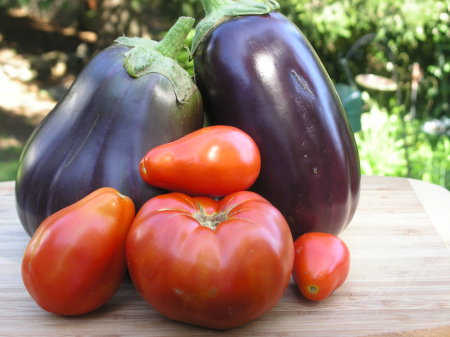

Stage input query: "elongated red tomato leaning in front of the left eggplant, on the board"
[{"left": 22, "top": 187, "right": 135, "bottom": 316}]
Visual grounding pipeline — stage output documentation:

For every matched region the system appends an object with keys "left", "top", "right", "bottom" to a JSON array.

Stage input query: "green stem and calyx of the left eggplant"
[{"left": 115, "top": 17, "right": 197, "bottom": 103}]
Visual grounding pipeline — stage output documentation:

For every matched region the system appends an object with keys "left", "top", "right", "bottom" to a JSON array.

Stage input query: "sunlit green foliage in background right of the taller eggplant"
[{"left": 280, "top": 0, "right": 450, "bottom": 189}]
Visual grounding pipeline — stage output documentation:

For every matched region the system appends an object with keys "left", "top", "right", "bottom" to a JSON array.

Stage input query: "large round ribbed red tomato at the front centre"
[{"left": 126, "top": 191, "right": 294, "bottom": 329}]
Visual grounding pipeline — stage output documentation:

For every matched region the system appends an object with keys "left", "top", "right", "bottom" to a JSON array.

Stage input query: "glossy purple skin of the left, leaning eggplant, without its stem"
[{"left": 16, "top": 45, "right": 203, "bottom": 235}]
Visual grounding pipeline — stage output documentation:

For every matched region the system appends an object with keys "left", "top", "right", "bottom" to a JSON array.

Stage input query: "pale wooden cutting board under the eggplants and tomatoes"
[{"left": 0, "top": 177, "right": 450, "bottom": 337}]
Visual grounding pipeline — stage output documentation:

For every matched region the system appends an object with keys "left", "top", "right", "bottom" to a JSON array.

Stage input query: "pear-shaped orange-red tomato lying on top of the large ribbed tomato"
[{"left": 139, "top": 125, "right": 261, "bottom": 196}]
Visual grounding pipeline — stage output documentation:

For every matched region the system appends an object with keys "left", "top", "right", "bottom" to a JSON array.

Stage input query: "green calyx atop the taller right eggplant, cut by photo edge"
[{"left": 191, "top": 0, "right": 280, "bottom": 55}]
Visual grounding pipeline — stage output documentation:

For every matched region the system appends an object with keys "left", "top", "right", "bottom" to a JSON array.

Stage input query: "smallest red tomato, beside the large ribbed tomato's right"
[{"left": 293, "top": 232, "right": 350, "bottom": 301}]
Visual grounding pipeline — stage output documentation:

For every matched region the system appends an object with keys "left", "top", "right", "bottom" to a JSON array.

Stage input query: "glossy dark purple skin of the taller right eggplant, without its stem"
[{"left": 194, "top": 12, "right": 360, "bottom": 239}]
